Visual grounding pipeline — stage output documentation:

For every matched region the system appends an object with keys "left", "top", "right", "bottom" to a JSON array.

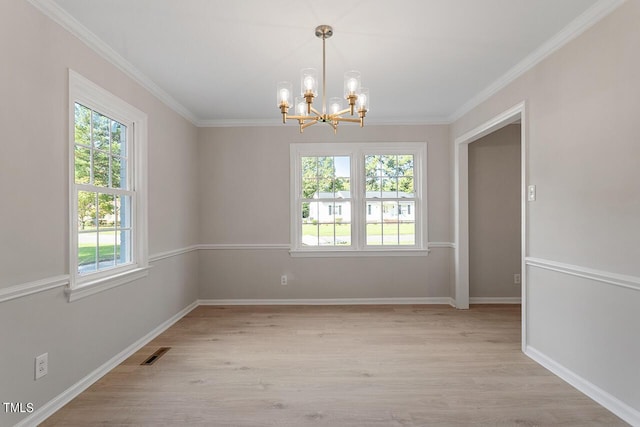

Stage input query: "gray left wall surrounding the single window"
[{"left": 0, "top": 0, "right": 198, "bottom": 426}]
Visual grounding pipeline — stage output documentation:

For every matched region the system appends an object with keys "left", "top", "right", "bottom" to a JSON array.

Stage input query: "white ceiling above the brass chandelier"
[{"left": 45, "top": 0, "right": 615, "bottom": 125}]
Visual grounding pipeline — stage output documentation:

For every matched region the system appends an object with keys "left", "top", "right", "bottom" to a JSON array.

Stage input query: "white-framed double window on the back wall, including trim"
[{"left": 291, "top": 143, "right": 427, "bottom": 254}]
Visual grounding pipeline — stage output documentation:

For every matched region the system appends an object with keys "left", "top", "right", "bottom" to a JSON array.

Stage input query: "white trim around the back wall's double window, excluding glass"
[{"left": 289, "top": 142, "right": 429, "bottom": 257}]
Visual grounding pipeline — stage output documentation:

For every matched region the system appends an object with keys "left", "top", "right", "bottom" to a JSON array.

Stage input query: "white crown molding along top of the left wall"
[{"left": 27, "top": 0, "right": 198, "bottom": 125}]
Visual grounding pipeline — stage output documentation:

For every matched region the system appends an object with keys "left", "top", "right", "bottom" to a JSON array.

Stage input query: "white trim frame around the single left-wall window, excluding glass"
[{"left": 65, "top": 69, "right": 149, "bottom": 301}]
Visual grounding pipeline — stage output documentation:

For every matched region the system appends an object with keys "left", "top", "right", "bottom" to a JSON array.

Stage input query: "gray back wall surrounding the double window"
[{"left": 199, "top": 125, "right": 452, "bottom": 299}]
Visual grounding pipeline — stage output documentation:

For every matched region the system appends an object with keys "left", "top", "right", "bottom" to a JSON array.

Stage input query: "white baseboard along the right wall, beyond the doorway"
[{"left": 525, "top": 346, "right": 640, "bottom": 426}]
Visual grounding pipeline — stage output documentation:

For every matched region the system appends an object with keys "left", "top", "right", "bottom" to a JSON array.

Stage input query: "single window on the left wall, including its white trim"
[{"left": 69, "top": 70, "right": 147, "bottom": 298}]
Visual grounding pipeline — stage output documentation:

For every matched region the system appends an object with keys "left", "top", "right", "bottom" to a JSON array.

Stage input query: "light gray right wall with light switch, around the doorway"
[{"left": 452, "top": 1, "right": 640, "bottom": 417}]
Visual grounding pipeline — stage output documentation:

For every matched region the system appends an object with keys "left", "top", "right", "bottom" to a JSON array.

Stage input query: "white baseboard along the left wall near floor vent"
[{"left": 14, "top": 301, "right": 198, "bottom": 427}]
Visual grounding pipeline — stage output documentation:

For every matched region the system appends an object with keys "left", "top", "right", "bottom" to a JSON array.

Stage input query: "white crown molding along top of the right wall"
[{"left": 447, "top": 0, "right": 626, "bottom": 123}]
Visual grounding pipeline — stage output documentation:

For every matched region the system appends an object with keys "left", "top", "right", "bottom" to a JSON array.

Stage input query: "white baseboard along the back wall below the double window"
[{"left": 198, "top": 297, "right": 454, "bottom": 305}]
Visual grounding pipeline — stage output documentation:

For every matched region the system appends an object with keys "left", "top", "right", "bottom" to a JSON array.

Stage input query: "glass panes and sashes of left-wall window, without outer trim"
[{"left": 74, "top": 102, "right": 134, "bottom": 276}]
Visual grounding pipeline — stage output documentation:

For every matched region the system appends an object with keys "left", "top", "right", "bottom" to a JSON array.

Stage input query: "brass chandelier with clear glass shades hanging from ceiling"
[{"left": 276, "top": 25, "right": 369, "bottom": 133}]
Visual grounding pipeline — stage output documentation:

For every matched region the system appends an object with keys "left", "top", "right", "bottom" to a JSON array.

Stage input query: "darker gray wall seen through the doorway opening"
[{"left": 469, "top": 124, "right": 522, "bottom": 298}]
